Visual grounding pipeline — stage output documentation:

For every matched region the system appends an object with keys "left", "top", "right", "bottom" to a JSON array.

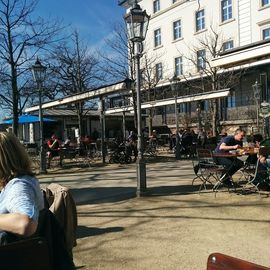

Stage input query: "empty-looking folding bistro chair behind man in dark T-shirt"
[{"left": 192, "top": 149, "right": 224, "bottom": 192}]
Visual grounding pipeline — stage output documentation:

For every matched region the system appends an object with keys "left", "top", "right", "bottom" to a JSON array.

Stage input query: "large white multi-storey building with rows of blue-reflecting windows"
[{"left": 119, "top": 0, "right": 270, "bottom": 135}]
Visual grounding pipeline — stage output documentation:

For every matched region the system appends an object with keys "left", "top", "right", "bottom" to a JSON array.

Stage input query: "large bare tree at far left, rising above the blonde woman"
[{"left": 0, "top": 0, "right": 61, "bottom": 135}]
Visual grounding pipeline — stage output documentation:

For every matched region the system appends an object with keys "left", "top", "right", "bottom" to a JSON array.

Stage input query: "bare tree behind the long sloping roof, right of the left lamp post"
[{"left": 51, "top": 31, "right": 103, "bottom": 134}]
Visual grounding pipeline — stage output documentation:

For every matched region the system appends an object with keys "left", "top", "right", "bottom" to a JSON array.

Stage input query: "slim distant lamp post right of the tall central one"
[{"left": 170, "top": 74, "right": 181, "bottom": 160}]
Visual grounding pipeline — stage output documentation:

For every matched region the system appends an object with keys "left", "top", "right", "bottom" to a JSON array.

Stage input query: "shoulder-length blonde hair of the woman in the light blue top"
[{"left": 0, "top": 132, "right": 34, "bottom": 186}]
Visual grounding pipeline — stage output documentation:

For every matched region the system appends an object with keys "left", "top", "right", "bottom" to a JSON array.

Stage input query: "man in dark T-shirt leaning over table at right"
[{"left": 214, "top": 128, "right": 246, "bottom": 186}]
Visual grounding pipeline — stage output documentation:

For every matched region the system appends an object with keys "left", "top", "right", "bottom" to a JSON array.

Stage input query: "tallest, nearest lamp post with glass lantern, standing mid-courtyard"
[{"left": 125, "top": 0, "right": 150, "bottom": 197}]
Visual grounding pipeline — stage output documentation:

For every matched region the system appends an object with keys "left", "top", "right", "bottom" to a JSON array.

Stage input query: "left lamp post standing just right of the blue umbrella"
[{"left": 32, "top": 58, "right": 47, "bottom": 173}]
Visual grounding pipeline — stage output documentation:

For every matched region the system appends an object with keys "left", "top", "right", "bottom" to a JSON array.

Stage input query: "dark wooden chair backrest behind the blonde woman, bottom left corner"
[{"left": 0, "top": 237, "right": 52, "bottom": 270}]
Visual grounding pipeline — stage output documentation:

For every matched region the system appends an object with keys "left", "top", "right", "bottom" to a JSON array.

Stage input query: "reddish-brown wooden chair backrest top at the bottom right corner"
[{"left": 207, "top": 253, "right": 270, "bottom": 270}]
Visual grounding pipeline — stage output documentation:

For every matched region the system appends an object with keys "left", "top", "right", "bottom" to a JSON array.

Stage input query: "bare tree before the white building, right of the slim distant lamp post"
[{"left": 180, "top": 27, "right": 244, "bottom": 136}]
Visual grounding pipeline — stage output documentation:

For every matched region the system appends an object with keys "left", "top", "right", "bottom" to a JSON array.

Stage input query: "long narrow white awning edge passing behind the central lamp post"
[{"left": 105, "top": 88, "right": 230, "bottom": 114}]
